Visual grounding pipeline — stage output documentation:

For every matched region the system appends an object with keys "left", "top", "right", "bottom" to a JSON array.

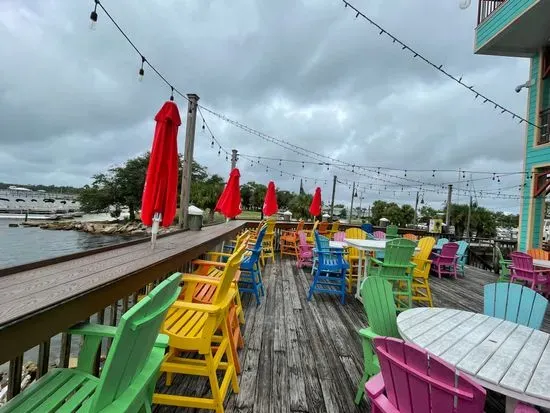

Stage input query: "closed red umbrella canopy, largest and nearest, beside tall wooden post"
[{"left": 141, "top": 101, "right": 181, "bottom": 227}]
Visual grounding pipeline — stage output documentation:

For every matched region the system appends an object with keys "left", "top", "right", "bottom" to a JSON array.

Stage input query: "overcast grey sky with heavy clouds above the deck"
[{"left": 0, "top": 0, "right": 529, "bottom": 212}]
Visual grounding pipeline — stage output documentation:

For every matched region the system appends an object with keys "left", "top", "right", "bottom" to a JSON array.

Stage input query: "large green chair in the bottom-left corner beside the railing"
[{"left": 0, "top": 273, "right": 181, "bottom": 413}]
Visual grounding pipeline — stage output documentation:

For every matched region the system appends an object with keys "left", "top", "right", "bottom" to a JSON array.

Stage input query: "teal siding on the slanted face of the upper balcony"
[{"left": 475, "top": 0, "right": 538, "bottom": 49}]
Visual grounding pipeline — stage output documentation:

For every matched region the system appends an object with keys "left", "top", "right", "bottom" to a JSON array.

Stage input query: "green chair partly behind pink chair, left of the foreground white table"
[{"left": 355, "top": 277, "right": 400, "bottom": 404}]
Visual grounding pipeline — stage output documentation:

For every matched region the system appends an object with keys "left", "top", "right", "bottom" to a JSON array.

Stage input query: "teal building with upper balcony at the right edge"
[{"left": 475, "top": 0, "right": 550, "bottom": 251}]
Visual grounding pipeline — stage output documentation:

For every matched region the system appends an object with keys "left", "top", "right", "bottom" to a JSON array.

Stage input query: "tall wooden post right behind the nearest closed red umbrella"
[{"left": 178, "top": 93, "right": 199, "bottom": 229}]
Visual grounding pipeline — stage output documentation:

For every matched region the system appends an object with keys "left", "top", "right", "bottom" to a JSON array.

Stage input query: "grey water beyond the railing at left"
[{"left": 0, "top": 217, "right": 137, "bottom": 268}]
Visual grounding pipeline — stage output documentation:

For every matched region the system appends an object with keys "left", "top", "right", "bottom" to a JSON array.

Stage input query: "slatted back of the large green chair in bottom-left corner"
[{"left": 90, "top": 273, "right": 181, "bottom": 412}]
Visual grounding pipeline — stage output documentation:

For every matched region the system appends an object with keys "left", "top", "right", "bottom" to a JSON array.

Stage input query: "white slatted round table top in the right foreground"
[{"left": 397, "top": 307, "right": 550, "bottom": 407}]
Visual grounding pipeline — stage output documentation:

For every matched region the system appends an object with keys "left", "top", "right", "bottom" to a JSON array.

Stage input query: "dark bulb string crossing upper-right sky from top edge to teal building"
[{"left": 342, "top": 0, "right": 540, "bottom": 129}]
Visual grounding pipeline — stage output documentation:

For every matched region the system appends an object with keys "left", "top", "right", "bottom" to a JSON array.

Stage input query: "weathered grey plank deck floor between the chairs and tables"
[{"left": 153, "top": 259, "right": 550, "bottom": 413}]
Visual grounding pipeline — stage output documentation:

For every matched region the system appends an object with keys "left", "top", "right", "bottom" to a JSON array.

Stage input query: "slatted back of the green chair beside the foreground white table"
[{"left": 361, "top": 277, "right": 400, "bottom": 337}]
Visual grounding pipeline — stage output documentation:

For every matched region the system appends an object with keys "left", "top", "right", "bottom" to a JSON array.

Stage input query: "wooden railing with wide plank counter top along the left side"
[{"left": 0, "top": 221, "right": 245, "bottom": 399}]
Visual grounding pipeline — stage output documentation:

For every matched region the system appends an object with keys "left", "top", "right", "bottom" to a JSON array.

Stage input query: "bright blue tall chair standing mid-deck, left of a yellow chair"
[{"left": 307, "top": 231, "right": 349, "bottom": 304}]
